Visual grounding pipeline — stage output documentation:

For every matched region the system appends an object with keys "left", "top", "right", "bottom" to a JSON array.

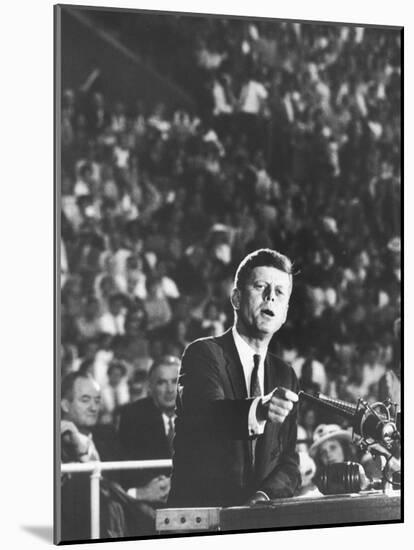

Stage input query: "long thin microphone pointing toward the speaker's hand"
[{"left": 298, "top": 391, "right": 400, "bottom": 449}]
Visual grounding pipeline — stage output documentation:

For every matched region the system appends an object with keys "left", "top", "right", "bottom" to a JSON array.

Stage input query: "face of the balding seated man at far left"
[{"left": 62, "top": 378, "right": 101, "bottom": 430}]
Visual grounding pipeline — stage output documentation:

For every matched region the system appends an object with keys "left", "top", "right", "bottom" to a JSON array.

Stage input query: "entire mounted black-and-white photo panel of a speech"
[{"left": 54, "top": 4, "right": 404, "bottom": 544}]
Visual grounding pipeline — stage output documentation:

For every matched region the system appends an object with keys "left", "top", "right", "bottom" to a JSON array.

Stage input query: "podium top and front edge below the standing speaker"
[{"left": 156, "top": 491, "right": 402, "bottom": 534}]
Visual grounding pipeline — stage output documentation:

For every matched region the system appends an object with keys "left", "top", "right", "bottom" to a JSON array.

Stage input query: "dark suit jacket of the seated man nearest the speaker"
[{"left": 119, "top": 397, "right": 171, "bottom": 487}]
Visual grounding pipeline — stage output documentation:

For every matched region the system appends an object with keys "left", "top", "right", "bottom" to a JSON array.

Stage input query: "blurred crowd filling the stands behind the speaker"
[{"left": 61, "top": 16, "right": 401, "bottom": 462}]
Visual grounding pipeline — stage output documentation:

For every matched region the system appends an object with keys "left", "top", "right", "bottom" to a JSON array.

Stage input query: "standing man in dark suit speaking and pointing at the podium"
[{"left": 168, "top": 249, "right": 300, "bottom": 508}]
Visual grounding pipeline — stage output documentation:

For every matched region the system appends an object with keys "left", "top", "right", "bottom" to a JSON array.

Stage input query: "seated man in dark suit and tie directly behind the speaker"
[{"left": 119, "top": 356, "right": 180, "bottom": 505}]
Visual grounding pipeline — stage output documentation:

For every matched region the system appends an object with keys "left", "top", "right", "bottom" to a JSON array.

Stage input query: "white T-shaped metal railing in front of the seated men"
[{"left": 61, "top": 458, "right": 172, "bottom": 539}]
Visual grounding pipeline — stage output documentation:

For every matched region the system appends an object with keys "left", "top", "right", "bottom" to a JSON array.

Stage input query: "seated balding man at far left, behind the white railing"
[{"left": 60, "top": 371, "right": 155, "bottom": 541}]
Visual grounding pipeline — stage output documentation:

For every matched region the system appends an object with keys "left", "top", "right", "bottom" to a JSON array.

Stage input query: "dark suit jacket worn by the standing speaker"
[{"left": 168, "top": 330, "right": 300, "bottom": 507}]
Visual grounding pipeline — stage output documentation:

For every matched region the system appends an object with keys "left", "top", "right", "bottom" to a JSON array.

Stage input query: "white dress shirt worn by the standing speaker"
[{"left": 232, "top": 326, "right": 267, "bottom": 435}]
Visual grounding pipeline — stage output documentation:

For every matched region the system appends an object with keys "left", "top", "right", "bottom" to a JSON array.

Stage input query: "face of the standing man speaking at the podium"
[{"left": 232, "top": 266, "right": 292, "bottom": 338}]
